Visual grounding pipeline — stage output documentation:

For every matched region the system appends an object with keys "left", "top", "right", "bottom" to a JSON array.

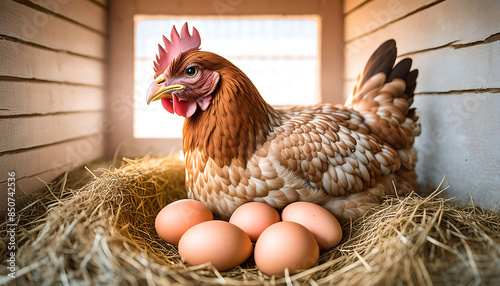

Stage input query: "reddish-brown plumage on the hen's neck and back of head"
[{"left": 180, "top": 51, "right": 273, "bottom": 167}]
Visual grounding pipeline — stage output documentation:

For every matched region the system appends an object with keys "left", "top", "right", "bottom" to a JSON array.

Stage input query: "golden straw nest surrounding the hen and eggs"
[{"left": 0, "top": 157, "right": 500, "bottom": 285}]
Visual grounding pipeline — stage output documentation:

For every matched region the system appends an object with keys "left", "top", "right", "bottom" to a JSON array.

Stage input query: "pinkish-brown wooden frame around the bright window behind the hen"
[{"left": 105, "top": 0, "right": 344, "bottom": 157}]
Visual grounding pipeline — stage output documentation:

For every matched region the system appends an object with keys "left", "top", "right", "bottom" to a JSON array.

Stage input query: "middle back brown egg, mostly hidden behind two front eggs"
[{"left": 229, "top": 202, "right": 280, "bottom": 242}]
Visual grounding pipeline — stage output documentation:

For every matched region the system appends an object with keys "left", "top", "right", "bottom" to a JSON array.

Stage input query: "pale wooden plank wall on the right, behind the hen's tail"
[{"left": 344, "top": 0, "right": 500, "bottom": 207}]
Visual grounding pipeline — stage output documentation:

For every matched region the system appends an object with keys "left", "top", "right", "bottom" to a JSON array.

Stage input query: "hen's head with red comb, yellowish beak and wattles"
[{"left": 147, "top": 23, "right": 219, "bottom": 118}]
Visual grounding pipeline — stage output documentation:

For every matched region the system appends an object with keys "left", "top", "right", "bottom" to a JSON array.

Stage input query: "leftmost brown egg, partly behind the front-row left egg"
[{"left": 155, "top": 199, "right": 213, "bottom": 245}]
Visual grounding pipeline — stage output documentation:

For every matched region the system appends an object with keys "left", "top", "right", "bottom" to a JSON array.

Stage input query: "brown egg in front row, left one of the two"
[{"left": 179, "top": 220, "right": 252, "bottom": 271}]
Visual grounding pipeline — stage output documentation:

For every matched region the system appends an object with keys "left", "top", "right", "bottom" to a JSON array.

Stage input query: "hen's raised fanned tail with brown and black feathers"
[{"left": 346, "top": 40, "right": 418, "bottom": 149}]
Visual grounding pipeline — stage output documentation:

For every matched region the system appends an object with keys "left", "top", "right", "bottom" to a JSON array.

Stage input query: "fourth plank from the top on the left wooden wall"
[{"left": 0, "top": 81, "right": 105, "bottom": 116}]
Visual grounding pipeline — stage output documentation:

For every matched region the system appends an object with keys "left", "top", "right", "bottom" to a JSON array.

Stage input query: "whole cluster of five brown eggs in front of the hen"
[{"left": 155, "top": 199, "right": 342, "bottom": 275}]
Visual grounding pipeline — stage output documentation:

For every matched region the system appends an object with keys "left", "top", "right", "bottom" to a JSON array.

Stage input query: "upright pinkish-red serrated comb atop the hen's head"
[{"left": 154, "top": 22, "right": 201, "bottom": 78}]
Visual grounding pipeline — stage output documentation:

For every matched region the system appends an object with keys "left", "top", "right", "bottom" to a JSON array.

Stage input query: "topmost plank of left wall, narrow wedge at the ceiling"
[{"left": 29, "top": 0, "right": 106, "bottom": 33}]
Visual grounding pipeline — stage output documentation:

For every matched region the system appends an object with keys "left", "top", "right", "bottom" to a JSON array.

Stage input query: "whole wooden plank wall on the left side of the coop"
[{"left": 0, "top": 0, "right": 110, "bottom": 209}]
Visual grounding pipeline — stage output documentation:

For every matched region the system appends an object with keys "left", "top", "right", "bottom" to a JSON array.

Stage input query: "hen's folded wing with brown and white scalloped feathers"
[{"left": 270, "top": 104, "right": 400, "bottom": 196}]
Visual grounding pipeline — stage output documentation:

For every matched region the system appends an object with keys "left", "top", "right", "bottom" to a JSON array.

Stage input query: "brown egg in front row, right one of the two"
[{"left": 254, "top": 221, "right": 319, "bottom": 276}]
